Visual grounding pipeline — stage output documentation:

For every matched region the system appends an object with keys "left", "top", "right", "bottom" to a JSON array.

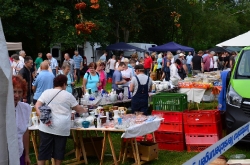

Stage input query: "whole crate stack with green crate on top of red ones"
[{"left": 152, "top": 93, "right": 187, "bottom": 151}]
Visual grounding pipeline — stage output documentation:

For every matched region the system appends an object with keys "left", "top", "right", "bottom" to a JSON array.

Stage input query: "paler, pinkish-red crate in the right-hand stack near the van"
[{"left": 185, "top": 134, "right": 219, "bottom": 144}]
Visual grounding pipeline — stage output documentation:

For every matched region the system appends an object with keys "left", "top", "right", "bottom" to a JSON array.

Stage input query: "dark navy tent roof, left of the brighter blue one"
[{"left": 96, "top": 42, "right": 146, "bottom": 52}]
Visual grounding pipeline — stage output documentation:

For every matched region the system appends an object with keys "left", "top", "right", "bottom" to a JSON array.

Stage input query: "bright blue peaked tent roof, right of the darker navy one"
[{"left": 149, "top": 42, "right": 194, "bottom": 51}]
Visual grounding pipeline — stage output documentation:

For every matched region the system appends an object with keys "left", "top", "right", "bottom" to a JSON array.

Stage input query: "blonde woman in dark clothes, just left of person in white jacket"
[{"left": 161, "top": 51, "right": 173, "bottom": 81}]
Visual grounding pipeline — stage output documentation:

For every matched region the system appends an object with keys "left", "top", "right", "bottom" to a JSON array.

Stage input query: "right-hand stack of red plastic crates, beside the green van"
[{"left": 183, "top": 110, "right": 222, "bottom": 152}]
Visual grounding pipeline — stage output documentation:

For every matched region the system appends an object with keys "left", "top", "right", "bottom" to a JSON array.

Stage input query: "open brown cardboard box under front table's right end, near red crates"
[{"left": 127, "top": 141, "right": 159, "bottom": 161}]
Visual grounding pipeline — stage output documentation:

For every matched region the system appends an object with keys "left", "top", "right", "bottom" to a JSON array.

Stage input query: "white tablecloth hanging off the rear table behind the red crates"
[{"left": 179, "top": 88, "right": 212, "bottom": 103}]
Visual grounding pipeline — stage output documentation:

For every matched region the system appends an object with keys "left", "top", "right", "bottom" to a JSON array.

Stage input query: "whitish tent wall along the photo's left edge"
[{"left": 0, "top": 19, "right": 20, "bottom": 165}]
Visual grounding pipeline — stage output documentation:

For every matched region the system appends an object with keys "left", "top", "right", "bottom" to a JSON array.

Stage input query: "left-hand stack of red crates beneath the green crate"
[{"left": 152, "top": 110, "right": 185, "bottom": 151}]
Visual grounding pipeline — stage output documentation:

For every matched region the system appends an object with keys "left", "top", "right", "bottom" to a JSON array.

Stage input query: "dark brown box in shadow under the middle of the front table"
[{"left": 83, "top": 137, "right": 103, "bottom": 156}]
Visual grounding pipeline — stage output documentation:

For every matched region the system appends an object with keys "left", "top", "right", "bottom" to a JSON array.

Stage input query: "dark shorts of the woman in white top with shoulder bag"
[{"left": 38, "top": 131, "right": 67, "bottom": 160}]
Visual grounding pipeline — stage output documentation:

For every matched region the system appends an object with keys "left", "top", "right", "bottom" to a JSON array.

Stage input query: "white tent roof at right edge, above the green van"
[{"left": 216, "top": 31, "right": 250, "bottom": 47}]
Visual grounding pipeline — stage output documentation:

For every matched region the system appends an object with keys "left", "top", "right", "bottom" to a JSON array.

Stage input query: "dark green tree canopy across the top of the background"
[{"left": 0, "top": 0, "right": 250, "bottom": 54}]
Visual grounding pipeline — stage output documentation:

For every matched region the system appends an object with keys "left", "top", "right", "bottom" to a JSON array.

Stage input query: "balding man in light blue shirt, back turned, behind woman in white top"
[{"left": 32, "top": 62, "right": 55, "bottom": 105}]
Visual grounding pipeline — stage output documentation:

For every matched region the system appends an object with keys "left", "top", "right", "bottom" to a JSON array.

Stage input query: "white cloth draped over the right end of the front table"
[{"left": 121, "top": 119, "right": 162, "bottom": 138}]
